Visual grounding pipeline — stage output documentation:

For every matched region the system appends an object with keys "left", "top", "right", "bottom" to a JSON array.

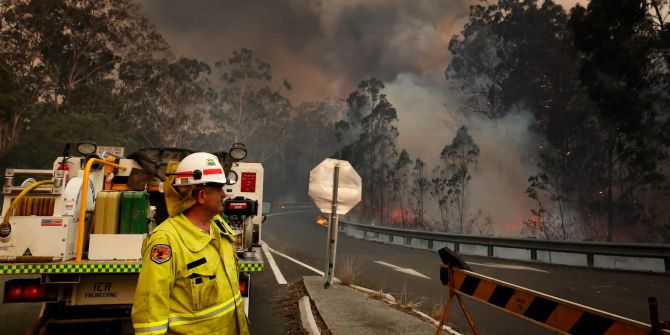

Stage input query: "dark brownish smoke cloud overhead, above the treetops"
[{"left": 142, "top": 0, "right": 472, "bottom": 104}]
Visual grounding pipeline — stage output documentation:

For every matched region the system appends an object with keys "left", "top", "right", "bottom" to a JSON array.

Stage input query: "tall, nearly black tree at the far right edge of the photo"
[{"left": 570, "top": 0, "right": 670, "bottom": 241}]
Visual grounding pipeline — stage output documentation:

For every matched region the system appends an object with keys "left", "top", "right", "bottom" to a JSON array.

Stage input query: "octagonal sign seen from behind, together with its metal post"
[{"left": 309, "top": 158, "right": 362, "bottom": 288}]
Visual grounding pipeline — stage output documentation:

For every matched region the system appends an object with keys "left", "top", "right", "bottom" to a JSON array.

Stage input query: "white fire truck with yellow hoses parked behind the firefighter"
[{"left": 0, "top": 142, "right": 270, "bottom": 334}]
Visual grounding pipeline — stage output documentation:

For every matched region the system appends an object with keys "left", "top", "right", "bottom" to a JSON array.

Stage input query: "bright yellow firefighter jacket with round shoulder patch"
[{"left": 132, "top": 214, "right": 249, "bottom": 334}]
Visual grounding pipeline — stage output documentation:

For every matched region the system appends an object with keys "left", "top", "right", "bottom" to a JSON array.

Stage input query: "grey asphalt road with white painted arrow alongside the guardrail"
[{"left": 263, "top": 210, "right": 670, "bottom": 334}]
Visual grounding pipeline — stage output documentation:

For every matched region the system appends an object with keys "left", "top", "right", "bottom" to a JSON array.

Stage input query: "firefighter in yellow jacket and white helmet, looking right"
[{"left": 132, "top": 152, "right": 249, "bottom": 334}]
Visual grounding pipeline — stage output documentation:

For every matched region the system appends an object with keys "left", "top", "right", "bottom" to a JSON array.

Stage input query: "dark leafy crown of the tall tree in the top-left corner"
[{"left": 0, "top": 0, "right": 168, "bottom": 151}]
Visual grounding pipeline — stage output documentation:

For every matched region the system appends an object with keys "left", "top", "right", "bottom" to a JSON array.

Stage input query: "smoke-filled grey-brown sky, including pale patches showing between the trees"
[{"left": 141, "top": 0, "right": 578, "bottom": 233}]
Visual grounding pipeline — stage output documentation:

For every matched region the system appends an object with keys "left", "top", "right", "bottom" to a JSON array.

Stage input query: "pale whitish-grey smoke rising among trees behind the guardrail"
[{"left": 385, "top": 73, "right": 540, "bottom": 235}]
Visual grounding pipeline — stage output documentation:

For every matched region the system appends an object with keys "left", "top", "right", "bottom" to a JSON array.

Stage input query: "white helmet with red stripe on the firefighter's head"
[{"left": 174, "top": 152, "right": 226, "bottom": 186}]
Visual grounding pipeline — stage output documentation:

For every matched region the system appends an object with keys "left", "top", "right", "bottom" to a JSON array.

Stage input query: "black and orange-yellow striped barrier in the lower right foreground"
[{"left": 437, "top": 248, "right": 670, "bottom": 335}]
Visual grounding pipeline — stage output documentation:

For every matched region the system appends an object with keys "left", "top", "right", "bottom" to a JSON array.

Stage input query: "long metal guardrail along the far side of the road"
[{"left": 340, "top": 221, "right": 670, "bottom": 274}]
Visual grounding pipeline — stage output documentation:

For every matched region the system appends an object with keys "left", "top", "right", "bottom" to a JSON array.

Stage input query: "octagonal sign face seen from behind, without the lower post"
[{"left": 309, "top": 158, "right": 363, "bottom": 214}]
